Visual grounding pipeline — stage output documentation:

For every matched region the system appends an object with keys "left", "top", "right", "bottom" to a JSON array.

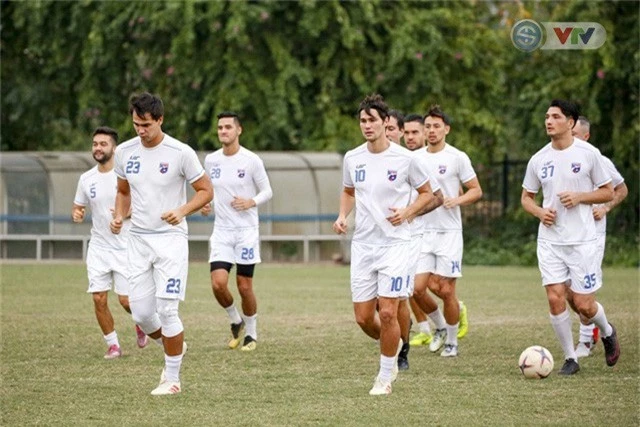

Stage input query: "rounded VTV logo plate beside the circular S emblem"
[{"left": 541, "top": 22, "right": 607, "bottom": 49}]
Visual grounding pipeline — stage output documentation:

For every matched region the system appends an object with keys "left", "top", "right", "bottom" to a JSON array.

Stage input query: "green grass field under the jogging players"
[{"left": 0, "top": 263, "right": 640, "bottom": 427}]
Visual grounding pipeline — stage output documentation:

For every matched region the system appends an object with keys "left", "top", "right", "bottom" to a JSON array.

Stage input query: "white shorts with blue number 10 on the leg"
[{"left": 351, "top": 241, "right": 411, "bottom": 302}]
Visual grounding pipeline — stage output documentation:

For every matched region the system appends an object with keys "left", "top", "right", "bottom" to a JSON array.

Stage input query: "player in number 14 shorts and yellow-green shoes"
[{"left": 413, "top": 105, "right": 482, "bottom": 357}]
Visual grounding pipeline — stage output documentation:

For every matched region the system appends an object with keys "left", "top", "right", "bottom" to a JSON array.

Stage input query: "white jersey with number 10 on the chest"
[{"left": 342, "top": 143, "right": 429, "bottom": 246}]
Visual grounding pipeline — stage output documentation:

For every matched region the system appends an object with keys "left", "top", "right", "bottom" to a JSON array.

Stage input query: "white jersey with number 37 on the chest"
[{"left": 522, "top": 138, "right": 611, "bottom": 245}]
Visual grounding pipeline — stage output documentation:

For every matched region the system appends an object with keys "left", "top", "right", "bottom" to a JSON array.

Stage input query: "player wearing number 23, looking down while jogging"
[{"left": 110, "top": 92, "right": 213, "bottom": 396}]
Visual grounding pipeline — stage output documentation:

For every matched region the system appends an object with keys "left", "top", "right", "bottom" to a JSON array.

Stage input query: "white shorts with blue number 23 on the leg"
[{"left": 128, "top": 233, "right": 189, "bottom": 301}]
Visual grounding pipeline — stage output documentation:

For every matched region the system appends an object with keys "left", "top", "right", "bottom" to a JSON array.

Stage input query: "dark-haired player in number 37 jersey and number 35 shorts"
[{"left": 521, "top": 100, "right": 620, "bottom": 375}]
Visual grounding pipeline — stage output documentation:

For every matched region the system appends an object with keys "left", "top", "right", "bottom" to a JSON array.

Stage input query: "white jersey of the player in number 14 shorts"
[{"left": 418, "top": 143, "right": 476, "bottom": 231}]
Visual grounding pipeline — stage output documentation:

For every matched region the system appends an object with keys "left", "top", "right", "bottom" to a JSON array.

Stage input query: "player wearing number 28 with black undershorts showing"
[{"left": 202, "top": 112, "right": 273, "bottom": 351}]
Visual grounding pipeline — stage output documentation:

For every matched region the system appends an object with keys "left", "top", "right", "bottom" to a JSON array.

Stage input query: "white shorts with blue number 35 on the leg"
[{"left": 537, "top": 240, "right": 602, "bottom": 294}]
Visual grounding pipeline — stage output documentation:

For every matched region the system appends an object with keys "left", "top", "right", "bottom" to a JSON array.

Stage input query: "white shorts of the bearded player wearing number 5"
[{"left": 87, "top": 243, "right": 129, "bottom": 295}]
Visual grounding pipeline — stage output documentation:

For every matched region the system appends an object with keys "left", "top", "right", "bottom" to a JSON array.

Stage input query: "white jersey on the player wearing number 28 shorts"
[{"left": 204, "top": 147, "right": 271, "bottom": 229}]
